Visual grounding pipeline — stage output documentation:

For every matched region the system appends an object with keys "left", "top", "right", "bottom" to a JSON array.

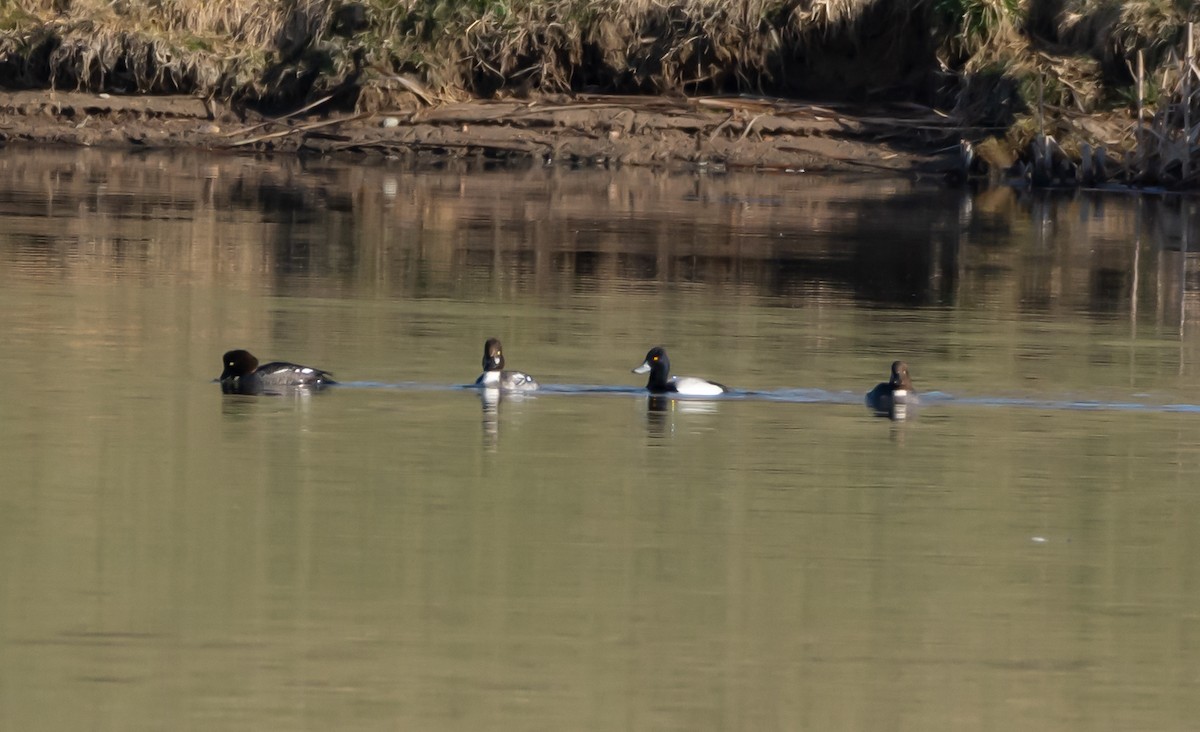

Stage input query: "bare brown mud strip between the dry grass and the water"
[{"left": 0, "top": 91, "right": 956, "bottom": 176}]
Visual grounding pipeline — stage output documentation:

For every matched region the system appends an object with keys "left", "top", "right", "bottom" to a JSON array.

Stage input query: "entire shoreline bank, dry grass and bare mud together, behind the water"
[{"left": 9, "top": 0, "right": 1200, "bottom": 191}]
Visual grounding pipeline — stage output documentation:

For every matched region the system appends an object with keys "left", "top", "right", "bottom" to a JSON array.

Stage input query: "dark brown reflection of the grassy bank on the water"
[{"left": 0, "top": 150, "right": 1200, "bottom": 318}]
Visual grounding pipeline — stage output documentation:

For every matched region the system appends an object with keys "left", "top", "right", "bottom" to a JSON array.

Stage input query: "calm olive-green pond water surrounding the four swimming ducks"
[{"left": 0, "top": 148, "right": 1200, "bottom": 731}]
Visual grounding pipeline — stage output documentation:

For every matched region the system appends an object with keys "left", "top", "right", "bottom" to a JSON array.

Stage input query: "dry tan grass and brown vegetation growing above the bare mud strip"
[{"left": 7, "top": 0, "right": 1200, "bottom": 186}]
